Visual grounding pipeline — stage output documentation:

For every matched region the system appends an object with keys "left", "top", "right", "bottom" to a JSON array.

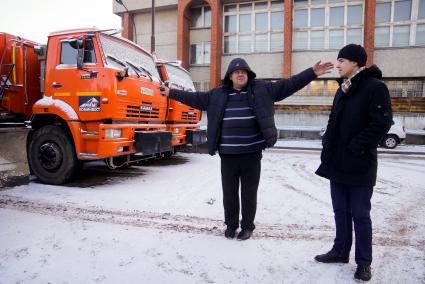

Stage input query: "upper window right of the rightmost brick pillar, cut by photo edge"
[{"left": 375, "top": 0, "right": 425, "bottom": 47}]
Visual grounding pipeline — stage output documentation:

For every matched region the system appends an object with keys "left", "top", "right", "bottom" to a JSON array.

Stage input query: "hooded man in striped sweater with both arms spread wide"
[{"left": 161, "top": 58, "right": 333, "bottom": 240}]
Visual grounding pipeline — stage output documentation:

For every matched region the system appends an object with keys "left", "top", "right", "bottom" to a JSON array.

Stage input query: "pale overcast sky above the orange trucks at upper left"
[{"left": 0, "top": 0, "right": 121, "bottom": 43}]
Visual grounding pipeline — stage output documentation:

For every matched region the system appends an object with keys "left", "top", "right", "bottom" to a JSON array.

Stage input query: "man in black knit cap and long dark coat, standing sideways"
[{"left": 315, "top": 44, "right": 392, "bottom": 281}]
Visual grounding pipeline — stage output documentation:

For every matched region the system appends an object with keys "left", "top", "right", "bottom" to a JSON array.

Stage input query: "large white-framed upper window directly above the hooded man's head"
[{"left": 223, "top": 0, "right": 284, "bottom": 54}]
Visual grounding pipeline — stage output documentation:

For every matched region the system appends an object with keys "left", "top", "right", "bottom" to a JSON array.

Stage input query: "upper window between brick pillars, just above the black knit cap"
[{"left": 293, "top": 0, "right": 363, "bottom": 50}]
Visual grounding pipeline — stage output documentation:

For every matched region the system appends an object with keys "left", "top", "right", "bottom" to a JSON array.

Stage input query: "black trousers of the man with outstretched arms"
[{"left": 220, "top": 151, "right": 262, "bottom": 230}]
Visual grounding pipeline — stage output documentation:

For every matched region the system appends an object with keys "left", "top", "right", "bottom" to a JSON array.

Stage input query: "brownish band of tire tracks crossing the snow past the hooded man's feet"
[{"left": 0, "top": 195, "right": 425, "bottom": 248}]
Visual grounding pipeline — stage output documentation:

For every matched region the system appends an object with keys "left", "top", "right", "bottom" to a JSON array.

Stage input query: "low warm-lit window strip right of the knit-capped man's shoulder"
[{"left": 384, "top": 79, "right": 425, "bottom": 97}]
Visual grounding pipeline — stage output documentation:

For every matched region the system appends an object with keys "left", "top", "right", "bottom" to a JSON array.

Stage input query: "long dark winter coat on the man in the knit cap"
[{"left": 316, "top": 65, "right": 392, "bottom": 186}]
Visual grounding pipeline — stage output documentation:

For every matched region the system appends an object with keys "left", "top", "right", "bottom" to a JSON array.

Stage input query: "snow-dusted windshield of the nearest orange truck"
[{"left": 100, "top": 34, "right": 159, "bottom": 82}]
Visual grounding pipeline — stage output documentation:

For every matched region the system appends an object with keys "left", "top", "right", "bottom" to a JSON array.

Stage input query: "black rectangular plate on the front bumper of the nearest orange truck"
[{"left": 134, "top": 131, "right": 173, "bottom": 156}]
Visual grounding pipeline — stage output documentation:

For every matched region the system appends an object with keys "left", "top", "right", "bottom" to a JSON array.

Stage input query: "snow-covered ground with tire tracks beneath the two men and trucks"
[{"left": 0, "top": 149, "right": 425, "bottom": 283}]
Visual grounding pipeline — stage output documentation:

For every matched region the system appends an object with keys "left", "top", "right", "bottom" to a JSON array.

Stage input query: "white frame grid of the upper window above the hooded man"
[{"left": 222, "top": 0, "right": 285, "bottom": 54}]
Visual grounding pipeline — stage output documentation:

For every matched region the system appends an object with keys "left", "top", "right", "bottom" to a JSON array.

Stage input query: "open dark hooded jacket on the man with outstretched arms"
[{"left": 169, "top": 60, "right": 316, "bottom": 155}]
